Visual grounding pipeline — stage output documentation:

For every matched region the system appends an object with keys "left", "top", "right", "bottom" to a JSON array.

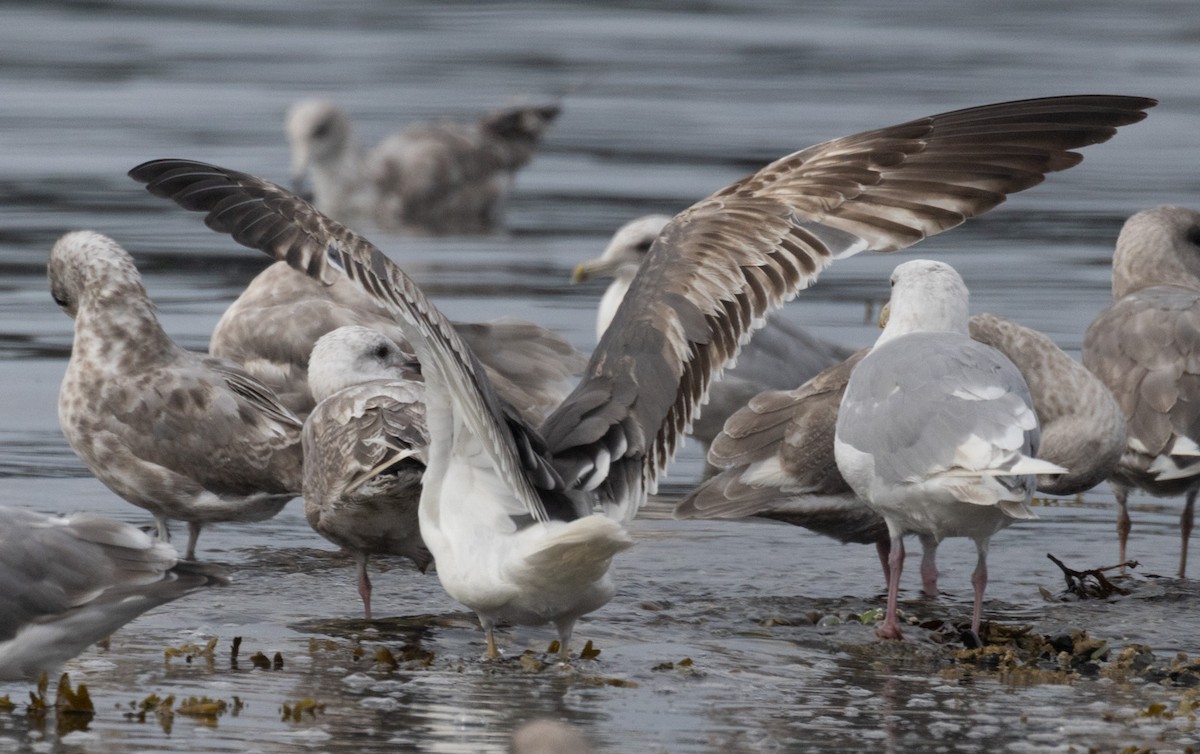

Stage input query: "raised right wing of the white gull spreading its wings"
[{"left": 542, "top": 96, "right": 1154, "bottom": 517}]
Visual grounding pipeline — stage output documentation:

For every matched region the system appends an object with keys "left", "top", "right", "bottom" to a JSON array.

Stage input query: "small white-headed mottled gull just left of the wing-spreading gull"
[{"left": 304, "top": 327, "right": 432, "bottom": 621}]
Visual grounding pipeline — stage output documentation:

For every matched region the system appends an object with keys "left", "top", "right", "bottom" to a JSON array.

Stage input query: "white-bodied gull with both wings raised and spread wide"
[{"left": 130, "top": 95, "right": 1153, "bottom": 659}]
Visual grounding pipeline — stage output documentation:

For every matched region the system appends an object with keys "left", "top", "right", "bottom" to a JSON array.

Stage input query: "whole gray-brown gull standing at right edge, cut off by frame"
[{"left": 1084, "top": 207, "right": 1200, "bottom": 579}]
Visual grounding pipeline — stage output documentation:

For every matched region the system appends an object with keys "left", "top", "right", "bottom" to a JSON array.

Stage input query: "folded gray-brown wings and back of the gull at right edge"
[{"left": 1084, "top": 286, "right": 1200, "bottom": 472}]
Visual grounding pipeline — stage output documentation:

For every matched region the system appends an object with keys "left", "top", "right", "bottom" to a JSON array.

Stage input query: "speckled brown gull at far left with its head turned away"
[{"left": 49, "top": 231, "right": 302, "bottom": 559}]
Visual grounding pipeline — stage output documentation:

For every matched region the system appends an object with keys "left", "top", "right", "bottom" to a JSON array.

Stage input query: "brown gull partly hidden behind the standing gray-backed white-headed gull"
[{"left": 674, "top": 313, "right": 1124, "bottom": 596}]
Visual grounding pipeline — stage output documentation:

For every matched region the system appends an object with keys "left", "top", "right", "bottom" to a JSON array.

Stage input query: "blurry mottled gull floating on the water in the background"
[{"left": 284, "top": 98, "right": 559, "bottom": 234}]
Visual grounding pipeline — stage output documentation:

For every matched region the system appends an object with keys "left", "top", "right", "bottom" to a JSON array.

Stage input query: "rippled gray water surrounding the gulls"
[{"left": 0, "top": 0, "right": 1200, "bottom": 752}]
